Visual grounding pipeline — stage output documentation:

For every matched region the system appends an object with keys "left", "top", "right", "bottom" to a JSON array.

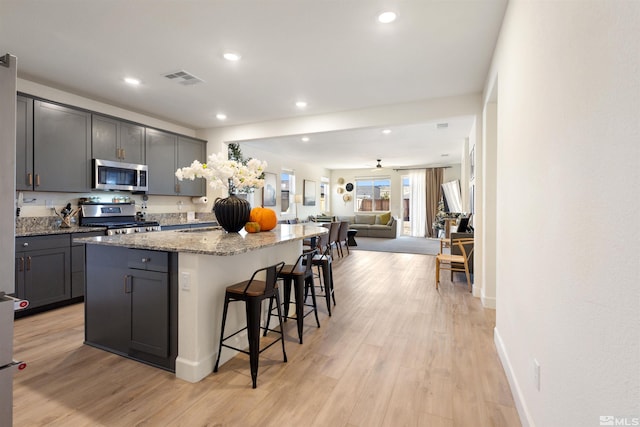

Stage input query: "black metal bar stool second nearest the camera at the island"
[{"left": 265, "top": 249, "right": 320, "bottom": 344}]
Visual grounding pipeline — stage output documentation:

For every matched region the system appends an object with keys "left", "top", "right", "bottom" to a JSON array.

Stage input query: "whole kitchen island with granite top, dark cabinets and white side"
[{"left": 76, "top": 224, "right": 327, "bottom": 382}]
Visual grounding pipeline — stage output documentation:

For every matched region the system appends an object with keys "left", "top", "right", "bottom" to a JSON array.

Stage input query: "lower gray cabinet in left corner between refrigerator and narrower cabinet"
[{"left": 15, "top": 234, "right": 71, "bottom": 309}]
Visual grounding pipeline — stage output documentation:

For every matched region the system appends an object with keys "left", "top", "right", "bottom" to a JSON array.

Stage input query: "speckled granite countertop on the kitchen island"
[{"left": 74, "top": 224, "right": 328, "bottom": 256}]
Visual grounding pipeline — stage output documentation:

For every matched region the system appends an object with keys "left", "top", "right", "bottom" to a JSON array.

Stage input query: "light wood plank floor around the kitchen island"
[{"left": 14, "top": 251, "right": 520, "bottom": 427}]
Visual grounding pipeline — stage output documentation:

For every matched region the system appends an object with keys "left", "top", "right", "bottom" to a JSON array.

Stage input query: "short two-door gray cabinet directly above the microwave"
[{"left": 91, "top": 114, "right": 145, "bottom": 164}]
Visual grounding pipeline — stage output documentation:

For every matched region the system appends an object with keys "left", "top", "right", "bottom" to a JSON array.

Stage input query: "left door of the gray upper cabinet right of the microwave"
[{"left": 145, "top": 128, "right": 178, "bottom": 196}]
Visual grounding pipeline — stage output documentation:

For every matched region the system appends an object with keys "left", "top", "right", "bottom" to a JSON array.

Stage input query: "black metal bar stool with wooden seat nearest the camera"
[{"left": 213, "top": 261, "right": 287, "bottom": 388}]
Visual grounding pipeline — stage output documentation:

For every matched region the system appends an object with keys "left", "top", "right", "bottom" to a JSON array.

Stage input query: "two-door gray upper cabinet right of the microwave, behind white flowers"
[{"left": 146, "top": 128, "right": 207, "bottom": 197}]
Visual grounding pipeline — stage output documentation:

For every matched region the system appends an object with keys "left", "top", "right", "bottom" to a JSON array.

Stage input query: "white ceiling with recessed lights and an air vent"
[{"left": 0, "top": 0, "right": 507, "bottom": 168}]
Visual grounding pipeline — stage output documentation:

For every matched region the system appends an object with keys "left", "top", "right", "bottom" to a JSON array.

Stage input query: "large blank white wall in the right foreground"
[{"left": 488, "top": 0, "right": 640, "bottom": 427}]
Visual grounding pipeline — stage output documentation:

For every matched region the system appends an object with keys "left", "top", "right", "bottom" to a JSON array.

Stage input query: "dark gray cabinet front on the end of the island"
[{"left": 85, "top": 244, "right": 177, "bottom": 371}]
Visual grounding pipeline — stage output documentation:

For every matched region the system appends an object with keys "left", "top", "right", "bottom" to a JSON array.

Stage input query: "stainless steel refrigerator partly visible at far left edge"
[{"left": 0, "top": 54, "right": 22, "bottom": 426}]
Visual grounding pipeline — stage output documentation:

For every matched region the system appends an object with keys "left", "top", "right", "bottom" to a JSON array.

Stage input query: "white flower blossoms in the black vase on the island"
[{"left": 176, "top": 153, "right": 267, "bottom": 193}]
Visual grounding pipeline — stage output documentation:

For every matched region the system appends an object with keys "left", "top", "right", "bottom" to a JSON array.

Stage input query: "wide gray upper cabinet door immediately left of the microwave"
[{"left": 33, "top": 101, "right": 91, "bottom": 192}]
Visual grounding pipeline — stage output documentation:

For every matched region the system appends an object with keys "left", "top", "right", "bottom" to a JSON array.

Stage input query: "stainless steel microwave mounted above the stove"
[{"left": 93, "top": 159, "right": 149, "bottom": 191}]
